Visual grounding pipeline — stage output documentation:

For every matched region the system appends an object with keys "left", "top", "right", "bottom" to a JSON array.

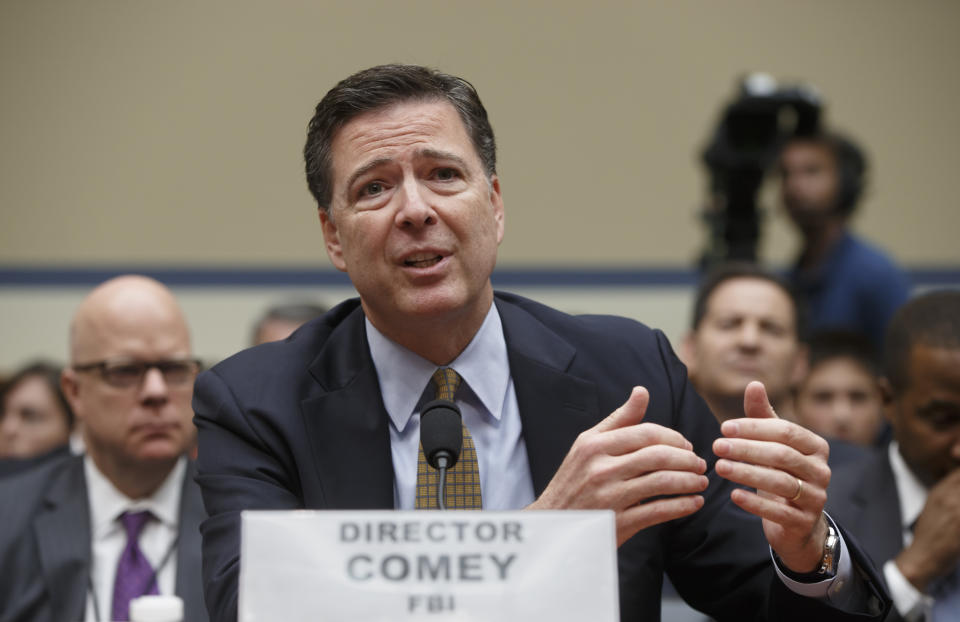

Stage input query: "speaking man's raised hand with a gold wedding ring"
[{"left": 713, "top": 382, "right": 830, "bottom": 573}]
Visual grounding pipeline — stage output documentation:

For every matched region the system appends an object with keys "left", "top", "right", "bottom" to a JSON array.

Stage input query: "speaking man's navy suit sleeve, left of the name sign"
[{"left": 193, "top": 370, "right": 303, "bottom": 622}]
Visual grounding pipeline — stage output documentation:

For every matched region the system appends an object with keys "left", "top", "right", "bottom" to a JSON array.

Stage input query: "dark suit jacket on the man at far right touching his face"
[{"left": 827, "top": 447, "right": 903, "bottom": 622}]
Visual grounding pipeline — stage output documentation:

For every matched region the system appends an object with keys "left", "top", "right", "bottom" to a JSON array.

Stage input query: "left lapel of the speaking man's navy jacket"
[{"left": 300, "top": 307, "right": 394, "bottom": 509}]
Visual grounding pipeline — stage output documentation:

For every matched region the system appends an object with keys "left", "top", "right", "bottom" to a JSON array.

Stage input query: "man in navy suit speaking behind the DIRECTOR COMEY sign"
[{"left": 194, "top": 65, "right": 885, "bottom": 621}]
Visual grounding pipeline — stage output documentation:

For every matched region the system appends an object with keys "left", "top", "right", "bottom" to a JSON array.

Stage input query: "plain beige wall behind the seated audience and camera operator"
[{"left": 0, "top": 0, "right": 960, "bottom": 368}]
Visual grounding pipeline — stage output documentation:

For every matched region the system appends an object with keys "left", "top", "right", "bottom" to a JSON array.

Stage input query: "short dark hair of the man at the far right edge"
[{"left": 883, "top": 289, "right": 960, "bottom": 392}]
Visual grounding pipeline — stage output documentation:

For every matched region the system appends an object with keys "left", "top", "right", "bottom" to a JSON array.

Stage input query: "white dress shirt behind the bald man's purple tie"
[{"left": 83, "top": 455, "right": 187, "bottom": 622}]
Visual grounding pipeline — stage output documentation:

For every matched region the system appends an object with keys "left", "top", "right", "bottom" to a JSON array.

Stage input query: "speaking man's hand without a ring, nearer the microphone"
[{"left": 528, "top": 387, "right": 707, "bottom": 546}]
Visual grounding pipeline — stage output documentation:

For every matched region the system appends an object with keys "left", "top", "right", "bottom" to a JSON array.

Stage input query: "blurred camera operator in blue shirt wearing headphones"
[{"left": 779, "top": 133, "right": 910, "bottom": 348}]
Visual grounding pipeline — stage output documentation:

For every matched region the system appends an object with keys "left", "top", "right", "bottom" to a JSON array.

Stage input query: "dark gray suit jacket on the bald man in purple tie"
[{"left": 0, "top": 456, "right": 207, "bottom": 622}]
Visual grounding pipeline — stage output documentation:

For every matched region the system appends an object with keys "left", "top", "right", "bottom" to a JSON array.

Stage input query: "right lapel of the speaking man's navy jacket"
[{"left": 496, "top": 299, "right": 603, "bottom": 496}]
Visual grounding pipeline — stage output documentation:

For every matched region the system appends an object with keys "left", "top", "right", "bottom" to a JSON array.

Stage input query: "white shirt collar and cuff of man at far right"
[{"left": 883, "top": 441, "right": 933, "bottom": 620}]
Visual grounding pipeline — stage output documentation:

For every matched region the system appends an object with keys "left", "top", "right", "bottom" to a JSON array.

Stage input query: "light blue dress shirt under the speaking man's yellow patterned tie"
[{"left": 366, "top": 304, "right": 535, "bottom": 510}]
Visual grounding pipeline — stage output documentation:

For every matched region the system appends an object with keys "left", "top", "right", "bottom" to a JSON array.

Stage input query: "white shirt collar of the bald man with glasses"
[{"left": 83, "top": 454, "right": 187, "bottom": 537}]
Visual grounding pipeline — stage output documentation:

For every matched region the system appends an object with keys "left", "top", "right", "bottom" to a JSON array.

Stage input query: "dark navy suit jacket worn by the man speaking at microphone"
[{"left": 194, "top": 293, "right": 885, "bottom": 622}]
